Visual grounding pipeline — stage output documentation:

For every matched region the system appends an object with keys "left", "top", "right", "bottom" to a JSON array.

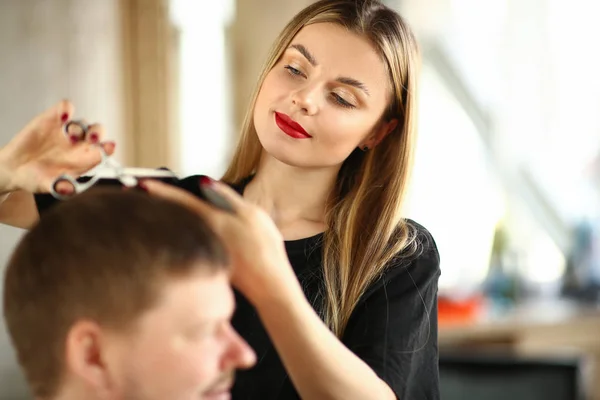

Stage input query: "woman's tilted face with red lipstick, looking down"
[{"left": 254, "top": 23, "right": 396, "bottom": 168}]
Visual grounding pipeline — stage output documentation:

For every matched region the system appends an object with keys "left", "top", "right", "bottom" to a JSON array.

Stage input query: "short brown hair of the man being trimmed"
[{"left": 4, "top": 188, "right": 229, "bottom": 397}]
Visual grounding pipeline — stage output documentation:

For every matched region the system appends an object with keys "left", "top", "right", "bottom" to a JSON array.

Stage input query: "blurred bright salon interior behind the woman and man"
[{"left": 0, "top": 0, "right": 600, "bottom": 400}]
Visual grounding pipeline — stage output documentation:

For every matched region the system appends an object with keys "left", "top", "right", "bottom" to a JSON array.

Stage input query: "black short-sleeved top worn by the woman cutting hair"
[{"left": 35, "top": 176, "right": 440, "bottom": 400}]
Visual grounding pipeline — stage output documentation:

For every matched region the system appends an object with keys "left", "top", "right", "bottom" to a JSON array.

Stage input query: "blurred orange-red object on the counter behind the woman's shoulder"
[{"left": 438, "top": 294, "right": 485, "bottom": 327}]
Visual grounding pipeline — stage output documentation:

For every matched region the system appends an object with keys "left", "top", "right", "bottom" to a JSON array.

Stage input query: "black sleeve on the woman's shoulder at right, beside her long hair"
[{"left": 342, "top": 224, "right": 440, "bottom": 400}]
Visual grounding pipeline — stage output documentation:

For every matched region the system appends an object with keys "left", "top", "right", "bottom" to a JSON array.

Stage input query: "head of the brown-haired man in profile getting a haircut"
[{"left": 4, "top": 189, "right": 255, "bottom": 400}]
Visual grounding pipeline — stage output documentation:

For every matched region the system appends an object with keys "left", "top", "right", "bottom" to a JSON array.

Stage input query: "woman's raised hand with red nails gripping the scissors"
[{"left": 0, "top": 100, "right": 115, "bottom": 193}]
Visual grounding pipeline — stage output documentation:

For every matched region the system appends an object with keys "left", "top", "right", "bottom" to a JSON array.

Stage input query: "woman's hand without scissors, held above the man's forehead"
[{"left": 144, "top": 179, "right": 300, "bottom": 306}]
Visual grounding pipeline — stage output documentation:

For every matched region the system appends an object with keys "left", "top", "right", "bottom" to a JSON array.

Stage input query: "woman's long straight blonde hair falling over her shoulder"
[{"left": 222, "top": 0, "right": 419, "bottom": 337}]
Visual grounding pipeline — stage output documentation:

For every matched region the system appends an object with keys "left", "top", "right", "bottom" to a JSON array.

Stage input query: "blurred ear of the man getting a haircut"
[{"left": 65, "top": 320, "right": 112, "bottom": 392}]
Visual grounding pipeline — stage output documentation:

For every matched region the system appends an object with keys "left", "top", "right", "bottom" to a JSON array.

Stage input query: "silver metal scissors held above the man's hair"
[{"left": 50, "top": 120, "right": 177, "bottom": 200}]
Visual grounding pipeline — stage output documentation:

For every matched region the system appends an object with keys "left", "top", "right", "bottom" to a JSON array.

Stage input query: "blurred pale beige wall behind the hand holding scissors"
[{"left": 0, "top": 0, "right": 123, "bottom": 400}]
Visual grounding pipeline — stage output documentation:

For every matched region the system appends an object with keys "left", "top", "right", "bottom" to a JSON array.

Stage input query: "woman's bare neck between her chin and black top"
[{"left": 244, "top": 156, "right": 339, "bottom": 240}]
